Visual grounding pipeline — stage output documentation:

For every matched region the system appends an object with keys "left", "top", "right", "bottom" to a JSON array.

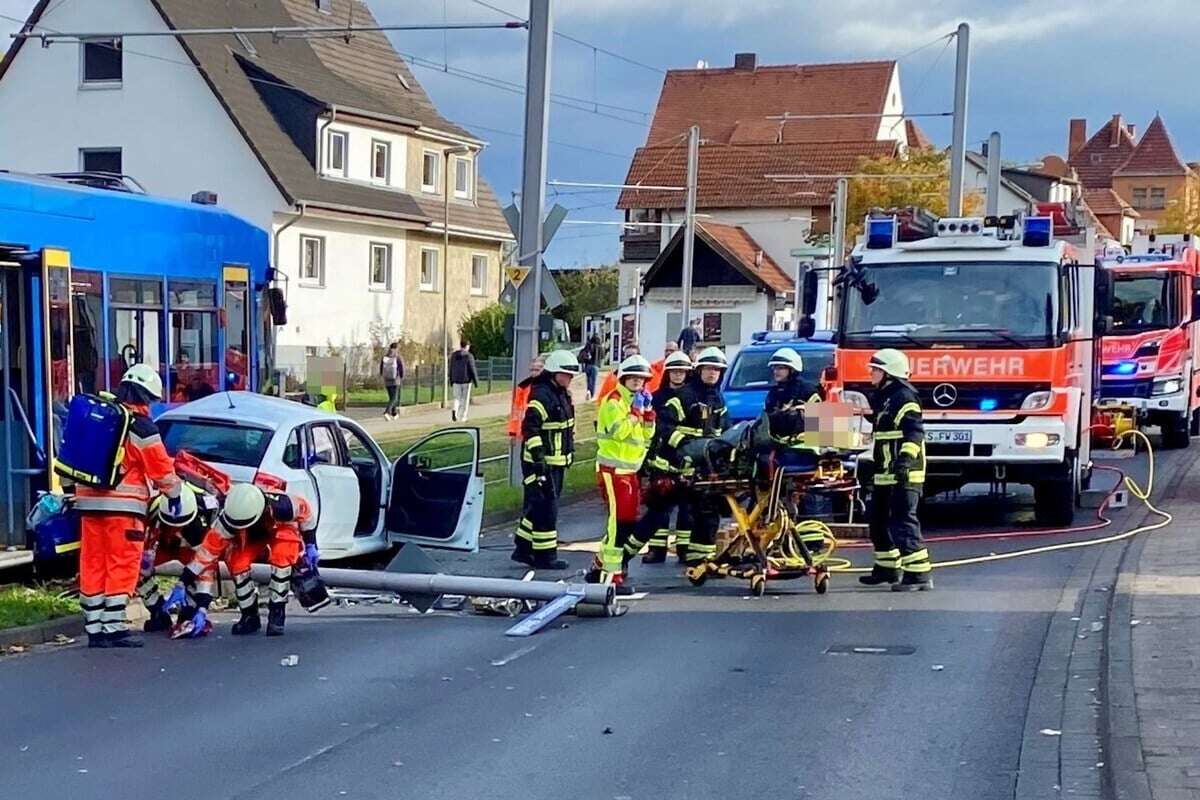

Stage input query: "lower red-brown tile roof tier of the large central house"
[{"left": 617, "top": 139, "right": 896, "bottom": 209}]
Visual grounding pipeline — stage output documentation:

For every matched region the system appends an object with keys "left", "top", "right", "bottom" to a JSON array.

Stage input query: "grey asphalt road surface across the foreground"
[{"left": 0, "top": 443, "right": 1182, "bottom": 800}]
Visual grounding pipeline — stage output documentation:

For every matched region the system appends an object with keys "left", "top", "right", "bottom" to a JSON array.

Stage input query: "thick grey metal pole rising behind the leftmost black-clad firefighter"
[{"left": 509, "top": 0, "right": 554, "bottom": 486}]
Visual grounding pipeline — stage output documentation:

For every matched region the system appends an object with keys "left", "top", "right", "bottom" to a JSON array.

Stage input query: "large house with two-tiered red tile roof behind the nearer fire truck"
[{"left": 617, "top": 53, "right": 929, "bottom": 351}]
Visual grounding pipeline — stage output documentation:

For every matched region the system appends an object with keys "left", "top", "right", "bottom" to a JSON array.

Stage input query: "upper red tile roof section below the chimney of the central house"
[{"left": 647, "top": 61, "right": 896, "bottom": 146}]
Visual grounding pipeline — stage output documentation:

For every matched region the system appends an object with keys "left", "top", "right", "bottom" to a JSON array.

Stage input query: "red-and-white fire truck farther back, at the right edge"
[{"left": 1096, "top": 234, "right": 1200, "bottom": 447}]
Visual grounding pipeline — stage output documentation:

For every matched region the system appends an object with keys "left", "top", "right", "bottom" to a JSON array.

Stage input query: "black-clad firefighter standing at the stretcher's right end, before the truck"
[{"left": 858, "top": 348, "right": 934, "bottom": 591}]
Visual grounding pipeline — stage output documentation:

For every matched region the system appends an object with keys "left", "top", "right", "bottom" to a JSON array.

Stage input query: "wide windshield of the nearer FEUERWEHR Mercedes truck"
[{"left": 842, "top": 261, "right": 1060, "bottom": 347}]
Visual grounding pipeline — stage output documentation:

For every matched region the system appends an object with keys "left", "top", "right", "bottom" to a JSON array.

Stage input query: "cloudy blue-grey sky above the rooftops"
[{"left": 0, "top": 0, "right": 1200, "bottom": 266}]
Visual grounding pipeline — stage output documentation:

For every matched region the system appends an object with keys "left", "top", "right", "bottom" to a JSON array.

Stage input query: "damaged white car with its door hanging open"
[{"left": 156, "top": 392, "right": 484, "bottom": 560}]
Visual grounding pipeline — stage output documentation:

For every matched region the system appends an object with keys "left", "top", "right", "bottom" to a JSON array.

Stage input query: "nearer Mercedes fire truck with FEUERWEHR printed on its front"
[{"left": 825, "top": 216, "right": 1098, "bottom": 525}]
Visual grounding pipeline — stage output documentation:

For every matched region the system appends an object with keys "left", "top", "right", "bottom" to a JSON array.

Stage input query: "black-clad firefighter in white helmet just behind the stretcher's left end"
[{"left": 664, "top": 347, "right": 728, "bottom": 570}]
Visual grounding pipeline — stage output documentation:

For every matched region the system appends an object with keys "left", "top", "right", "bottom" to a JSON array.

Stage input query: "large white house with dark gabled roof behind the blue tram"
[{"left": 0, "top": 0, "right": 511, "bottom": 373}]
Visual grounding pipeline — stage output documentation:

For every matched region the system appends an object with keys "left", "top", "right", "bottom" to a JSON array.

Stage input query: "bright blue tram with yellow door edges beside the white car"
[{"left": 0, "top": 172, "right": 270, "bottom": 555}]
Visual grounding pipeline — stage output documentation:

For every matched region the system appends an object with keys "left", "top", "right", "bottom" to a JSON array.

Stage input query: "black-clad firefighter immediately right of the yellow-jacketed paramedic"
[{"left": 626, "top": 350, "right": 692, "bottom": 564}]
